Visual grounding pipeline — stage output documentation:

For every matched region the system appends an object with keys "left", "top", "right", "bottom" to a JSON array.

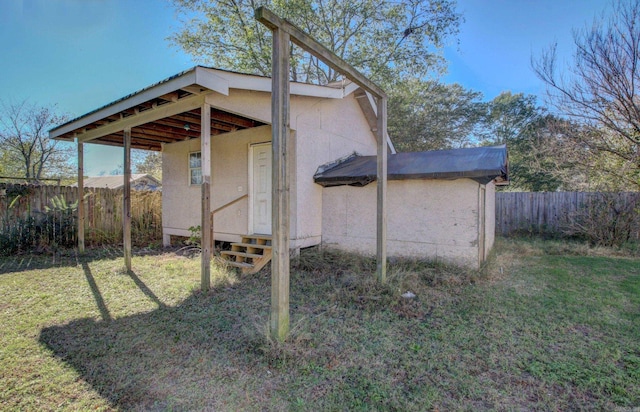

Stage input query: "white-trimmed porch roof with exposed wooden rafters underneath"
[{"left": 49, "top": 66, "right": 357, "bottom": 150}]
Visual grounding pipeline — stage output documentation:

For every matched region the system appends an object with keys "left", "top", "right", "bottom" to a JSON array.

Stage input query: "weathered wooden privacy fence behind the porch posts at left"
[{"left": 0, "top": 184, "right": 162, "bottom": 252}]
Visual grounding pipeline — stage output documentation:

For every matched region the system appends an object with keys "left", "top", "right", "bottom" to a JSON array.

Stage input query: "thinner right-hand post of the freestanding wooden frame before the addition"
[{"left": 376, "top": 96, "right": 387, "bottom": 282}]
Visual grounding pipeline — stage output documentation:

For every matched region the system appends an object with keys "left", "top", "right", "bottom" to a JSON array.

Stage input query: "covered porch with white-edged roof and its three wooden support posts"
[{"left": 50, "top": 66, "right": 269, "bottom": 289}]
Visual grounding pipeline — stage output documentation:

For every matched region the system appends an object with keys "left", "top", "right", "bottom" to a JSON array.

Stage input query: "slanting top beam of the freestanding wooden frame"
[{"left": 255, "top": 7, "right": 386, "bottom": 97}]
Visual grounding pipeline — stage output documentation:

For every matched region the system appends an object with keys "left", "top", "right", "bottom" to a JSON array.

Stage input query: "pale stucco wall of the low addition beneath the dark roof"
[{"left": 322, "top": 179, "right": 493, "bottom": 268}]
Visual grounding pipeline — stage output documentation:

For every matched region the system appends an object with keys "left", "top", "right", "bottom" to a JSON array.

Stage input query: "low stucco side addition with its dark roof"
[{"left": 314, "top": 145, "right": 508, "bottom": 268}]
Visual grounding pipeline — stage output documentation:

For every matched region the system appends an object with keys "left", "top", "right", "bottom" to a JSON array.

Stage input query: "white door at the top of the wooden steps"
[{"left": 251, "top": 143, "right": 271, "bottom": 235}]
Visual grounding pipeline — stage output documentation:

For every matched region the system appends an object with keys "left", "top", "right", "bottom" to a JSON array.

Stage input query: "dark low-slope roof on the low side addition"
[{"left": 313, "top": 145, "right": 508, "bottom": 187}]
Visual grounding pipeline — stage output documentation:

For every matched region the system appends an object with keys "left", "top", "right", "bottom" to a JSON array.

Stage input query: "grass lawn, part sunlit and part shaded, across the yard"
[{"left": 0, "top": 240, "right": 640, "bottom": 411}]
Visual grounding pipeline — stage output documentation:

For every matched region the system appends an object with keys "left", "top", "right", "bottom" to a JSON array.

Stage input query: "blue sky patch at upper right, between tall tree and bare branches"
[{"left": 443, "top": 0, "right": 609, "bottom": 100}]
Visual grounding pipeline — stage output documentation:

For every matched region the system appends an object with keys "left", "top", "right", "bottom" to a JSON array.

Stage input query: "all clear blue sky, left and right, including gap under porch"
[{"left": 0, "top": 0, "right": 607, "bottom": 175}]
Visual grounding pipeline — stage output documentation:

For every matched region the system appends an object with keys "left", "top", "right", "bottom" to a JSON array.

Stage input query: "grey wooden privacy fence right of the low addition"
[{"left": 496, "top": 192, "right": 640, "bottom": 241}]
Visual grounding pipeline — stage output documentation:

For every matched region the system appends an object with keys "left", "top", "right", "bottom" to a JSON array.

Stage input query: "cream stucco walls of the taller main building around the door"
[{"left": 163, "top": 89, "right": 376, "bottom": 248}]
